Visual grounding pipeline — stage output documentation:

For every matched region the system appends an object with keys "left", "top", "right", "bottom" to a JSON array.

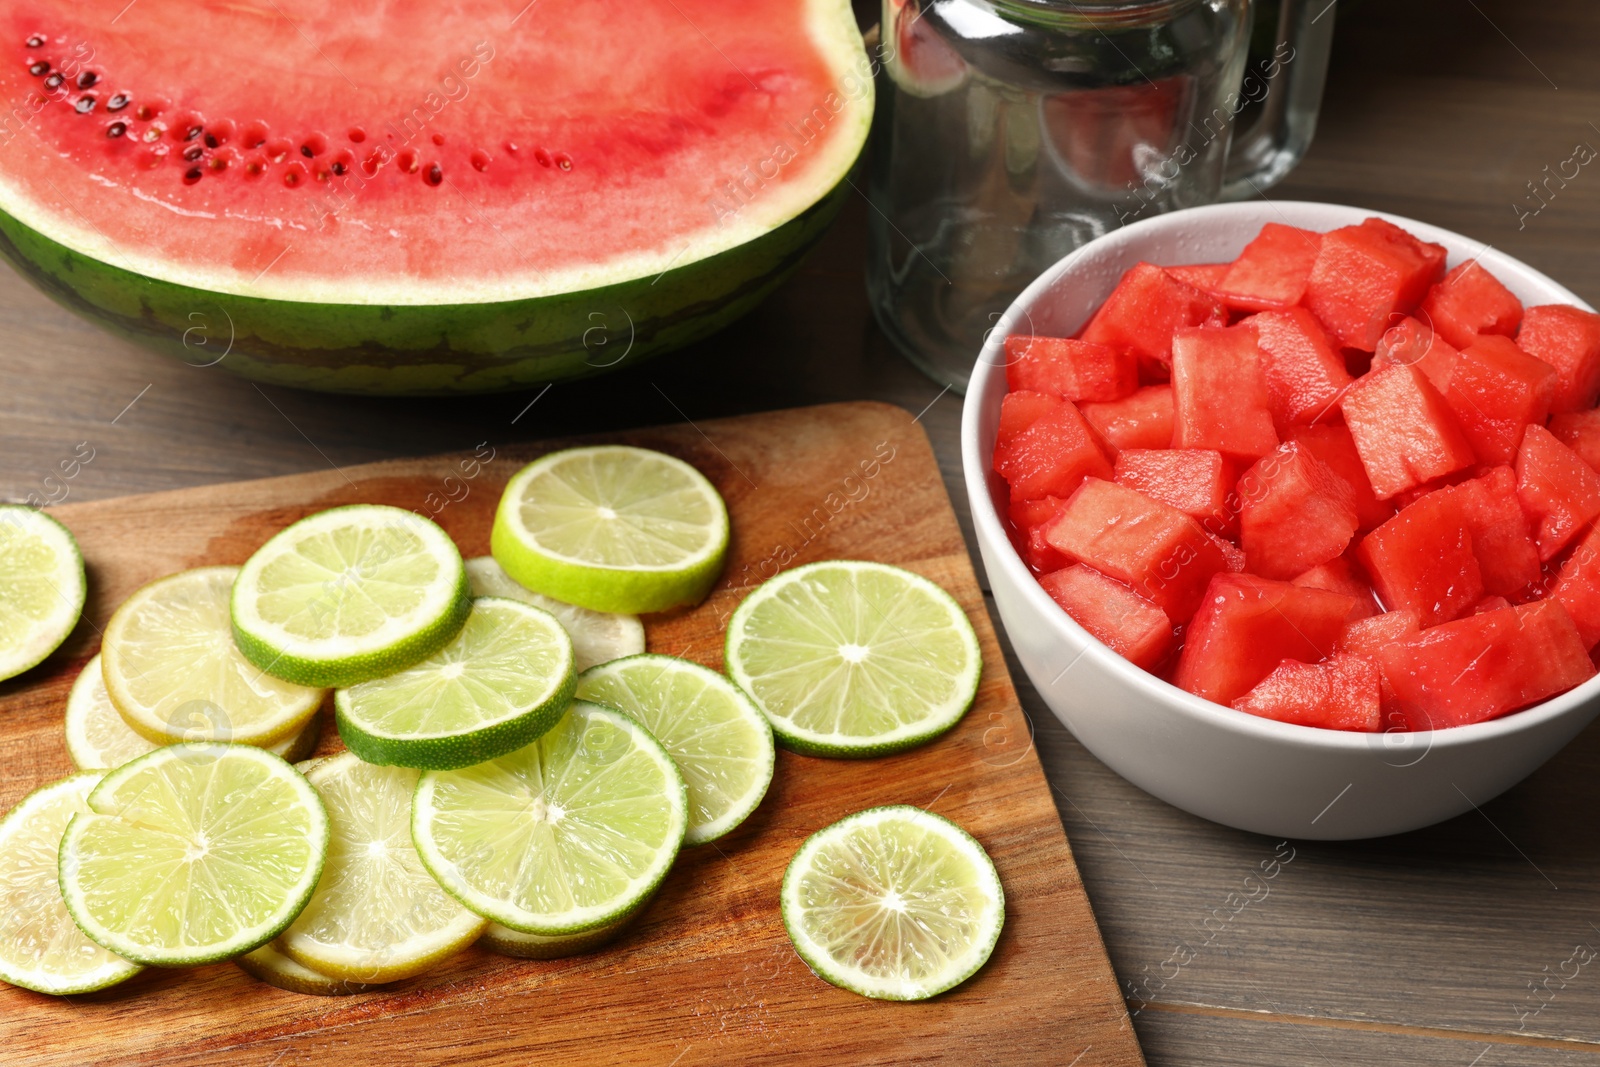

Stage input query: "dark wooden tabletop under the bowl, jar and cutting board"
[{"left": 9, "top": 0, "right": 1600, "bottom": 1067}]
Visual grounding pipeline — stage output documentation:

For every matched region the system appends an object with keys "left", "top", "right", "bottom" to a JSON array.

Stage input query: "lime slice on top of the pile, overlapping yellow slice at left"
[{"left": 234, "top": 504, "right": 470, "bottom": 686}]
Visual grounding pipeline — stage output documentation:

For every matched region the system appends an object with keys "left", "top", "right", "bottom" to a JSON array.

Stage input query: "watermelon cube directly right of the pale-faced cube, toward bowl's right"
[{"left": 1445, "top": 333, "right": 1555, "bottom": 464}]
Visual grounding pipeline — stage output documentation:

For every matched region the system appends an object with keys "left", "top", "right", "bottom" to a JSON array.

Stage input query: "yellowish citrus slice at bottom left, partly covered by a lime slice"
[{"left": 0, "top": 774, "right": 141, "bottom": 993}]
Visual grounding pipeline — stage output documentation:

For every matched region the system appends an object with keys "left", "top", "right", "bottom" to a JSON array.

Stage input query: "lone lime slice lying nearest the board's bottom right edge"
[{"left": 781, "top": 805, "right": 1005, "bottom": 1000}]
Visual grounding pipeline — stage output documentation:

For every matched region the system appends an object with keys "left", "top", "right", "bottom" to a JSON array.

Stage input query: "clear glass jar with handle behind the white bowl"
[{"left": 867, "top": 0, "right": 1333, "bottom": 390}]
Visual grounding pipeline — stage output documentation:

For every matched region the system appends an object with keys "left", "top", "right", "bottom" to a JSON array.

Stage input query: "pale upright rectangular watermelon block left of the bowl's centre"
[{"left": 1173, "top": 326, "right": 1278, "bottom": 459}]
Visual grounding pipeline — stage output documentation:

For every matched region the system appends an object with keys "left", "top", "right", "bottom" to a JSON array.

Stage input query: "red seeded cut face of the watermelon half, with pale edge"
[{"left": 0, "top": 0, "right": 870, "bottom": 304}]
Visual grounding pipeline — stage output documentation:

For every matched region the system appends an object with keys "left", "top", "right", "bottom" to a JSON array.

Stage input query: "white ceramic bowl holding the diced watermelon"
[{"left": 962, "top": 200, "right": 1600, "bottom": 840}]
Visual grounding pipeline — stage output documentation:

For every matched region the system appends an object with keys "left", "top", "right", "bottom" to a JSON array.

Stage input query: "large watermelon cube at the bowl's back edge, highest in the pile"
[{"left": 1302, "top": 219, "right": 1446, "bottom": 352}]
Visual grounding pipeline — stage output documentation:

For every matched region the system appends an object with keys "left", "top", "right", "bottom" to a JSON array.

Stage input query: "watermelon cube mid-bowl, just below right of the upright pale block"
[{"left": 1238, "top": 442, "right": 1357, "bottom": 581}]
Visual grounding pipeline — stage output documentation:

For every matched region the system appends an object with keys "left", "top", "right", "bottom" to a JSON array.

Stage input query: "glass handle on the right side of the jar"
[{"left": 1222, "top": 0, "right": 1338, "bottom": 200}]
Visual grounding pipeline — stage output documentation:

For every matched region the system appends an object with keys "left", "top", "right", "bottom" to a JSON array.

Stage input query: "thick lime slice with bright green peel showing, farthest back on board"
[{"left": 490, "top": 445, "right": 728, "bottom": 614}]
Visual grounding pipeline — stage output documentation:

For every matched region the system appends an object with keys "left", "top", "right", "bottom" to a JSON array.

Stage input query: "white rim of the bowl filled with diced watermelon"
[{"left": 962, "top": 200, "right": 1600, "bottom": 752}]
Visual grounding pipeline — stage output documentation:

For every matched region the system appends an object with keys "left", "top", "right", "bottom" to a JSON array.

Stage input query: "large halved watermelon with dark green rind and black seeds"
[{"left": 0, "top": 0, "right": 872, "bottom": 394}]
